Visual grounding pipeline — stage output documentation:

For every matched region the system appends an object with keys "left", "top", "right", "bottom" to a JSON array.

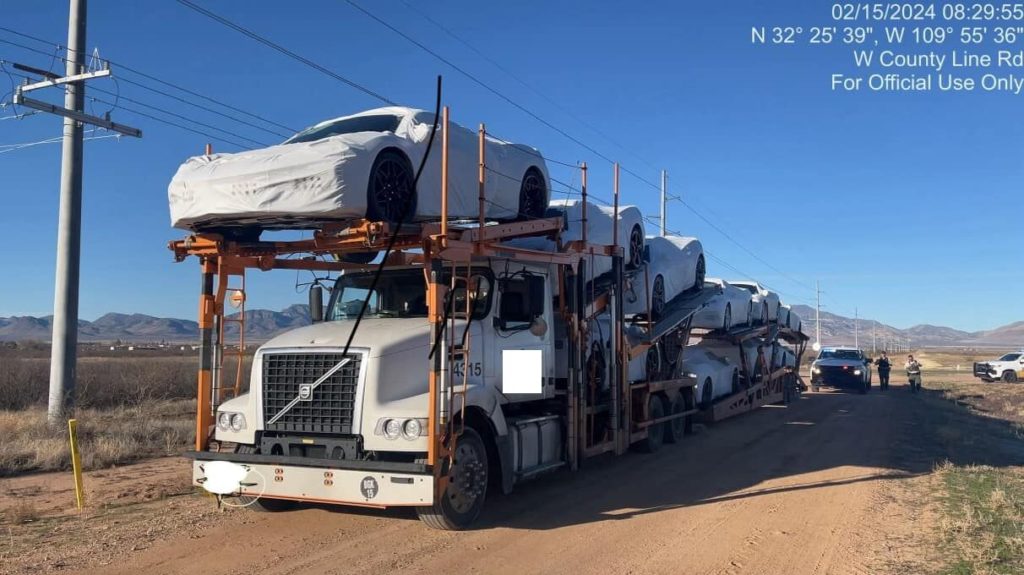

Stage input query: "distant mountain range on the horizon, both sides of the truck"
[{"left": 0, "top": 304, "right": 1024, "bottom": 348}]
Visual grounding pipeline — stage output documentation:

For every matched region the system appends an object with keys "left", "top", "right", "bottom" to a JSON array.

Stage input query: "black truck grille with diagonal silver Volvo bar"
[{"left": 263, "top": 353, "right": 361, "bottom": 434}]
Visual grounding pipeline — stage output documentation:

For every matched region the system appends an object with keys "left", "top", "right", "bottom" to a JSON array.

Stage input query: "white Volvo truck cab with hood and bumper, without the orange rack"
[{"left": 194, "top": 260, "right": 564, "bottom": 527}]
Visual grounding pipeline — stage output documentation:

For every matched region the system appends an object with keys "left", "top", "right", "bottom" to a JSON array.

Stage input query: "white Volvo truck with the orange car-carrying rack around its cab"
[{"left": 170, "top": 110, "right": 717, "bottom": 529}]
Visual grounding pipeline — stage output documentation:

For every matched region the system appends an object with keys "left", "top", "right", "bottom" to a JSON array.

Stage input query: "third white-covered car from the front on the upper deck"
[{"left": 625, "top": 235, "right": 707, "bottom": 319}]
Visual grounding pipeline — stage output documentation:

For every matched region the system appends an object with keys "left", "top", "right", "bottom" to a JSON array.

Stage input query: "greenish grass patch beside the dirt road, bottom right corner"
[{"left": 936, "top": 463, "right": 1024, "bottom": 575}]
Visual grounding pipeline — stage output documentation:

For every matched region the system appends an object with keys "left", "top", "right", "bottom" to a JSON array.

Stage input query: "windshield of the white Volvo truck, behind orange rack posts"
[{"left": 327, "top": 268, "right": 490, "bottom": 321}]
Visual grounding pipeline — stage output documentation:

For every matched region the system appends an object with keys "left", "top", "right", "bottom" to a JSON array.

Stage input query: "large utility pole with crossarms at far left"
[{"left": 12, "top": 0, "right": 142, "bottom": 426}]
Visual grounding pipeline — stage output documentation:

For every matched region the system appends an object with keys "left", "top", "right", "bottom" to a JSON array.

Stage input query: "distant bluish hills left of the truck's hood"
[{"left": 0, "top": 304, "right": 309, "bottom": 343}]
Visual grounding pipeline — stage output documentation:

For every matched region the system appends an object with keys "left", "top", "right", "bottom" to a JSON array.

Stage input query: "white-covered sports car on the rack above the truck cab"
[{"left": 168, "top": 106, "right": 549, "bottom": 235}]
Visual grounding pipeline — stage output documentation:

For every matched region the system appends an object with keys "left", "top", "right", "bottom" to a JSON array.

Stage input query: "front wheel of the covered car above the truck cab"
[{"left": 367, "top": 148, "right": 417, "bottom": 223}]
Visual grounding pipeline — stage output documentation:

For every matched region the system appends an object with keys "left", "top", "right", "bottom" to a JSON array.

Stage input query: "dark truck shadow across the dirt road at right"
[{"left": 462, "top": 385, "right": 1024, "bottom": 530}]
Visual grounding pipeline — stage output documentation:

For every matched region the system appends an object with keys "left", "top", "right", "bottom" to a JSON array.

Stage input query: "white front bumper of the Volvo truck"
[{"left": 186, "top": 451, "right": 434, "bottom": 507}]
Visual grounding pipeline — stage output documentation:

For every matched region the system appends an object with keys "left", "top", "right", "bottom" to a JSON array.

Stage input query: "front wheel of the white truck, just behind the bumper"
[{"left": 416, "top": 428, "right": 487, "bottom": 531}]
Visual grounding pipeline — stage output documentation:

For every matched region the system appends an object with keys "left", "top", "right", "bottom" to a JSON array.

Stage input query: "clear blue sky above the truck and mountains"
[{"left": 0, "top": 0, "right": 1024, "bottom": 329}]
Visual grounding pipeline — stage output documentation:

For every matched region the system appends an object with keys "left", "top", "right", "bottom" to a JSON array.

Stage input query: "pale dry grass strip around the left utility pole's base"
[{"left": 0, "top": 399, "right": 196, "bottom": 476}]
